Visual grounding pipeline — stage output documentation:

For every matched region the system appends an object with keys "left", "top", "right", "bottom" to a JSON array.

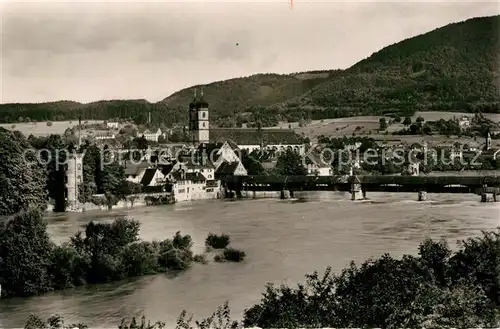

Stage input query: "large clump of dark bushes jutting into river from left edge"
[{"left": 0, "top": 210, "right": 193, "bottom": 297}]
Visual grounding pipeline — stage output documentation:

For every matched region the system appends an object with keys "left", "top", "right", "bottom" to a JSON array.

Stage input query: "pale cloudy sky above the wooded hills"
[{"left": 0, "top": 0, "right": 500, "bottom": 103}]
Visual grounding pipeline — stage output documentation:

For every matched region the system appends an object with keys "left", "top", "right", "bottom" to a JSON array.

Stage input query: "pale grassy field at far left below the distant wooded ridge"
[{"left": 0, "top": 120, "right": 103, "bottom": 137}]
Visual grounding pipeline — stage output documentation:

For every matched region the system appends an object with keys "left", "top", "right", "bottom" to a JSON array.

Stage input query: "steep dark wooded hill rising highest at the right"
[{"left": 275, "top": 16, "right": 500, "bottom": 119}]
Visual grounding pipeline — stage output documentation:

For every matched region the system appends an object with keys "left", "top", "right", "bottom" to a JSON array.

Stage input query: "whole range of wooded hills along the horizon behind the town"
[{"left": 0, "top": 16, "right": 500, "bottom": 126}]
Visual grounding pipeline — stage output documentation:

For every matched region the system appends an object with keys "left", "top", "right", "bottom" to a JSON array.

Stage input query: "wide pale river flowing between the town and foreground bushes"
[{"left": 0, "top": 192, "right": 500, "bottom": 328}]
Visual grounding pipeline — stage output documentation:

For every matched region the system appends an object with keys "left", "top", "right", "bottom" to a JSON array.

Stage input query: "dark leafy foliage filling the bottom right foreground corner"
[{"left": 244, "top": 230, "right": 500, "bottom": 328}]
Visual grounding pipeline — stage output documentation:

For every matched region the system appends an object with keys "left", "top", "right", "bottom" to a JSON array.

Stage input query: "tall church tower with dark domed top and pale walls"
[{"left": 189, "top": 90, "right": 210, "bottom": 144}]
